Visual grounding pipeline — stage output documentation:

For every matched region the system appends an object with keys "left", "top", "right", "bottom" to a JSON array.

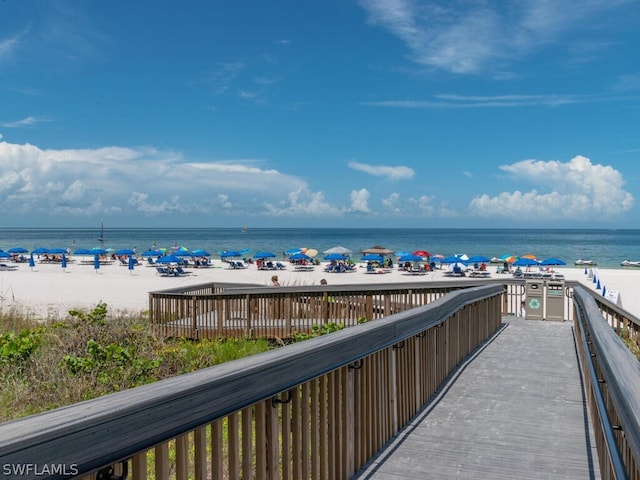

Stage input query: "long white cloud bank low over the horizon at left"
[{"left": 0, "top": 142, "right": 312, "bottom": 220}]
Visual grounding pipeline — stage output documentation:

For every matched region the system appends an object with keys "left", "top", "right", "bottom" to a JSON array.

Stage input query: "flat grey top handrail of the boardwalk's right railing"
[{"left": 574, "top": 287, "right": 640, "bottom": 470}]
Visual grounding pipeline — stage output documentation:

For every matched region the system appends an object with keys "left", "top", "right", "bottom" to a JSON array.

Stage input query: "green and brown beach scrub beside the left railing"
[{"left": 0, "top": 303, "right": 273, "bottom": 422}]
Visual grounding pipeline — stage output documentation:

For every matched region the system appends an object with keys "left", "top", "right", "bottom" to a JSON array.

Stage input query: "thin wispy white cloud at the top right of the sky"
[{"left": 359, "top": 0, "right": 633, "bottom": 74}]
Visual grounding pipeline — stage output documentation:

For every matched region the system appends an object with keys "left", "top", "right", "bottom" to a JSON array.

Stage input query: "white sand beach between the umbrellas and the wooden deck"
[{"left": 0, "top": 260, "right": 640, "bottom": 318}]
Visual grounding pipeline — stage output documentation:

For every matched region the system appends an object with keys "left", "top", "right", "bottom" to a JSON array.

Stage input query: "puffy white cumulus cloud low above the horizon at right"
[{"left": 469, "top": 156, "right": 635, "bottom": 221}]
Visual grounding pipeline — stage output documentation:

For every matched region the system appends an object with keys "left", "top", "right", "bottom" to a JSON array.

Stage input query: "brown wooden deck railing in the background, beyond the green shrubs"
[{"left": 149, "top": 280, "right": 532, "bottom": 338}]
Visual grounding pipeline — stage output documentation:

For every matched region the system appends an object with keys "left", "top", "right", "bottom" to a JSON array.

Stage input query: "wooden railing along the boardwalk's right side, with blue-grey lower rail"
[{"left": 574, "top": 288, "right": 640, "bottom": 479}]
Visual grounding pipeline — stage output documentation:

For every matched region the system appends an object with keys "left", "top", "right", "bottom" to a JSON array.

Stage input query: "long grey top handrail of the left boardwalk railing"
[{"left": 0, "top": 285, "right": 503, "bottom": 472}]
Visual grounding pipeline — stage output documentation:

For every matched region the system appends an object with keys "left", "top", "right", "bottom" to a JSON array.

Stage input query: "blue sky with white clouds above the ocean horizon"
[{"left": 0, "top": 0, "right": 640, "bottom": 228}]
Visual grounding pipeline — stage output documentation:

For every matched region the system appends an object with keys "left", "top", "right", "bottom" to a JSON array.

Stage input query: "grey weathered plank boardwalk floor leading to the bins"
[{"left": 355, "top": 317, "right": 600, "bottom": 480}]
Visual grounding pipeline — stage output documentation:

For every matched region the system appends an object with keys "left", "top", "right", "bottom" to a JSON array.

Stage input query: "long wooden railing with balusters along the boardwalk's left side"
[{"left": 0, "top": 284, "right": 504, "bottom": 480}]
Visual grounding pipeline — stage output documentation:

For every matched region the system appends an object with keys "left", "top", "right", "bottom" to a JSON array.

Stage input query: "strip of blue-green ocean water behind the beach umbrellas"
[{"left": 0, "top": 228, "right": 640, "bottom": 268}]
